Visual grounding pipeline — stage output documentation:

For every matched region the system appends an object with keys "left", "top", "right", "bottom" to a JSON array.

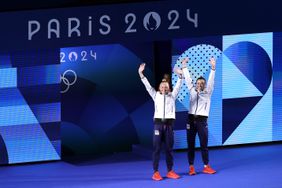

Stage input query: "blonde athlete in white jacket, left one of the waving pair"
[{"left": 138, "top": 63, "right": 182, "bottom": 181}]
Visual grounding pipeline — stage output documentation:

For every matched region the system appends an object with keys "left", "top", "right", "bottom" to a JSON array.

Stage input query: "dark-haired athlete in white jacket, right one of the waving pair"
[{"left": 182, "top": 58, "right": 216, "bottom": 175}]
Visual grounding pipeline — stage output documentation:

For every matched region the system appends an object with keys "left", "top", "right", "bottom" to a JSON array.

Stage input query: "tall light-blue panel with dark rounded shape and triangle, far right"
[{"left": 223, "top": 33, "right": 273, "bottom": 145}]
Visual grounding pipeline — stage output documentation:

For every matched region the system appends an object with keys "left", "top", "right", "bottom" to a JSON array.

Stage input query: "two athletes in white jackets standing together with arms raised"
[{"left": 138, "top": 58, "right": 216, "bottom": 181}]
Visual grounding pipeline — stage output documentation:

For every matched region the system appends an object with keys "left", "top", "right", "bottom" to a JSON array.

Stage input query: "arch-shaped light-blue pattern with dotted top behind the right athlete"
[{"left": 172, "top": 44, "right": 222, "bottom": 149}]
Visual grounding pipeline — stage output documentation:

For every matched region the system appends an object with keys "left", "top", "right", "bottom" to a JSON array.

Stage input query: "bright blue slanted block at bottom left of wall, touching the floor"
[{"left": 0, "top": 123, "right": 60, "bottom": 164}]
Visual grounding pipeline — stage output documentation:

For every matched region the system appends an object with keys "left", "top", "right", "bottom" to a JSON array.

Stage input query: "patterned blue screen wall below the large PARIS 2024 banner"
[{"left": 0, "top": 33, "right": 282, "bottom": 164}]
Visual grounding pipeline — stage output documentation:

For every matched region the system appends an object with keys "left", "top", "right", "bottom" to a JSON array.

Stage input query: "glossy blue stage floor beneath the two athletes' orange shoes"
[{"left": 0, "top": 143, "right": 282, "bottom": 188}]
